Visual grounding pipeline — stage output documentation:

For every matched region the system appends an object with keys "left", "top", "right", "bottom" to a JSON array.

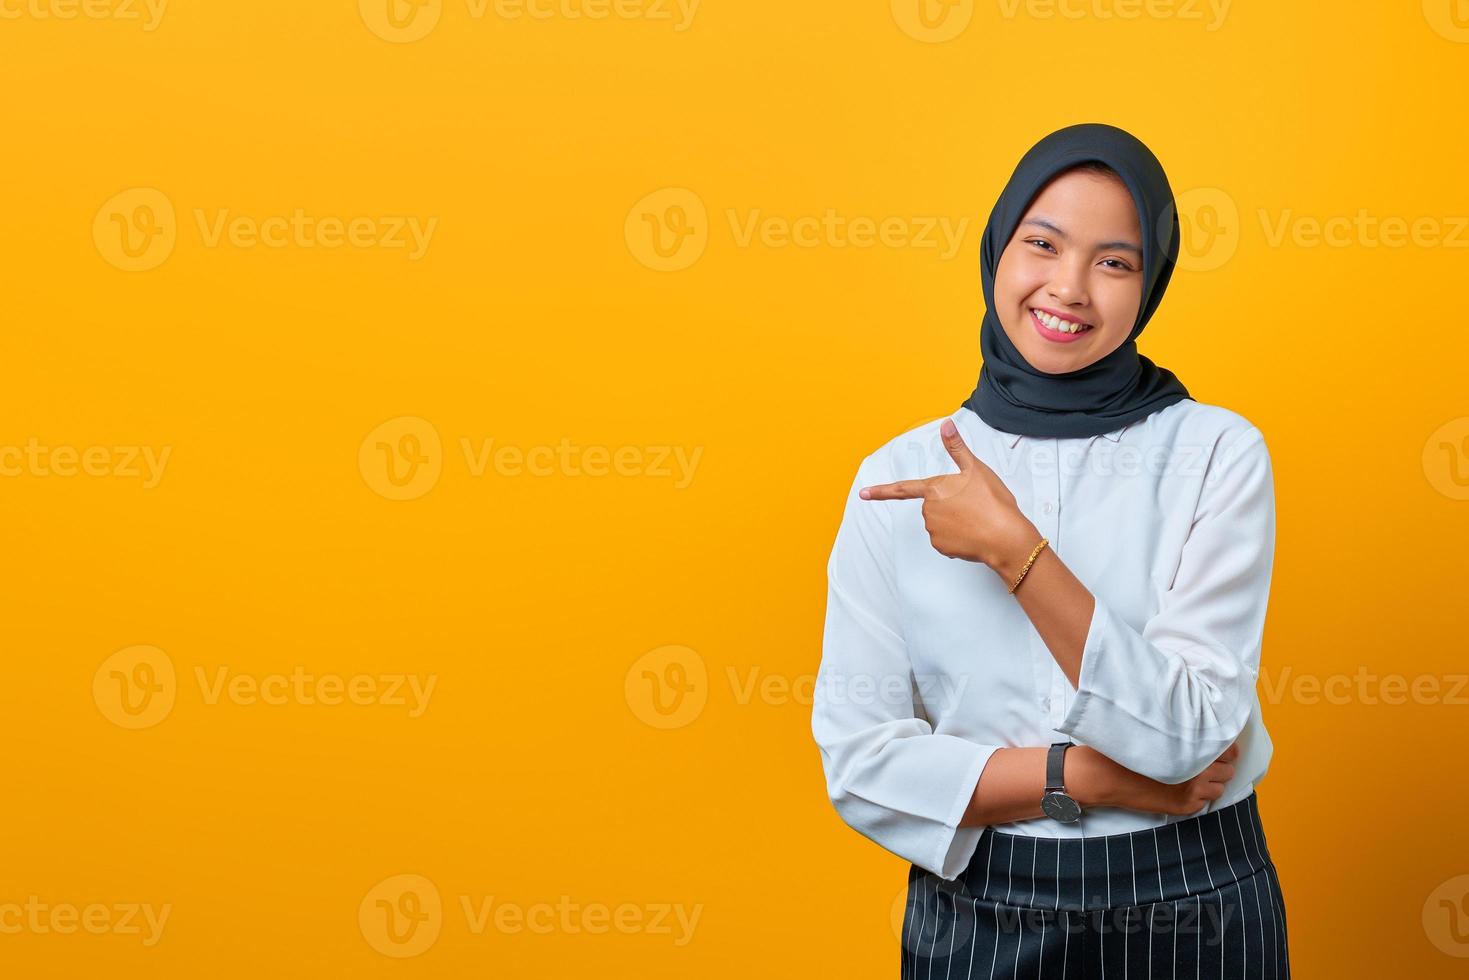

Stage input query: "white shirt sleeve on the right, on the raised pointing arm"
[{"left": 1058, "top": 426, "right": 1275, "bottom": 783}]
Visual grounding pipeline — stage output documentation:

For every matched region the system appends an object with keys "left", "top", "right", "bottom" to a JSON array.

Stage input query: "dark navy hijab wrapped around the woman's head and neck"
[{"left": 964, "top": 122, "right": 1190, "bottom": 438}]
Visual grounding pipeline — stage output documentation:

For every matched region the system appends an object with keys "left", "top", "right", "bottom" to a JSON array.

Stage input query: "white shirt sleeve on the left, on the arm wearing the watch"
[{"left": 811, "top": 453, "right": 1000, "bottom": 880}]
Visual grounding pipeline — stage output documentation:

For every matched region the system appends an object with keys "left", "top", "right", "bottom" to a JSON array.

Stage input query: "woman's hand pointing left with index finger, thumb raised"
[{"left": 859, "top": 419, "right": 1040, "bottom": 570}]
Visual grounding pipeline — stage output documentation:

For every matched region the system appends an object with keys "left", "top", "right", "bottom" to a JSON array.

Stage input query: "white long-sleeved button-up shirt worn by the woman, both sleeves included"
[{"left": 811, "top": 400, "right": 1275, "bottom": 880}]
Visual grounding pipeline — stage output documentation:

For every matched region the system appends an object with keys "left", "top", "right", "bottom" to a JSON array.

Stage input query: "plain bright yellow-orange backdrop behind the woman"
[{"left": 0, "top": 0, "right": 1469, "bottom": 980}]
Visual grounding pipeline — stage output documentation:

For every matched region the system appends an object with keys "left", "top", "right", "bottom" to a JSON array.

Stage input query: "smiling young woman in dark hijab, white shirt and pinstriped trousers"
[{"left": 811, "top": 123, "right": 1290, "bottom": 980}]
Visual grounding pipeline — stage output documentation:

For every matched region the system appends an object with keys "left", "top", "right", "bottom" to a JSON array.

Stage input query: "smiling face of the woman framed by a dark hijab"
[{"left": 995, "top": 170, "right": 1143, "bottom": 375}]
